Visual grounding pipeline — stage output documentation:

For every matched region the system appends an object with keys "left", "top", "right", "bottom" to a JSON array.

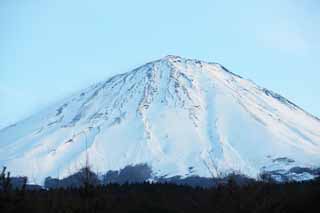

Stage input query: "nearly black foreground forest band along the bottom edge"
[{"left": 0, "top": 172, "right": 320, "bottom": 213}]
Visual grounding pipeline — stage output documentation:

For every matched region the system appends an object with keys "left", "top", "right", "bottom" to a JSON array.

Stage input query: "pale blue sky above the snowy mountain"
[{"left": 0, "top": 0, "right": 320, "bottom": 128}]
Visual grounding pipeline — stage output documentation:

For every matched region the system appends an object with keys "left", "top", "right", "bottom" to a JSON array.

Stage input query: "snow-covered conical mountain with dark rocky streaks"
[{"left": 0, "top": 56, "right": 320, "bottom": 183}]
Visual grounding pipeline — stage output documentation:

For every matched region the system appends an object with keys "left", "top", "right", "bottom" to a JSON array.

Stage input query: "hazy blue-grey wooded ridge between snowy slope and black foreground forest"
[{"left": 44, "top": 164, "right": 258, "bottom": 189}]
